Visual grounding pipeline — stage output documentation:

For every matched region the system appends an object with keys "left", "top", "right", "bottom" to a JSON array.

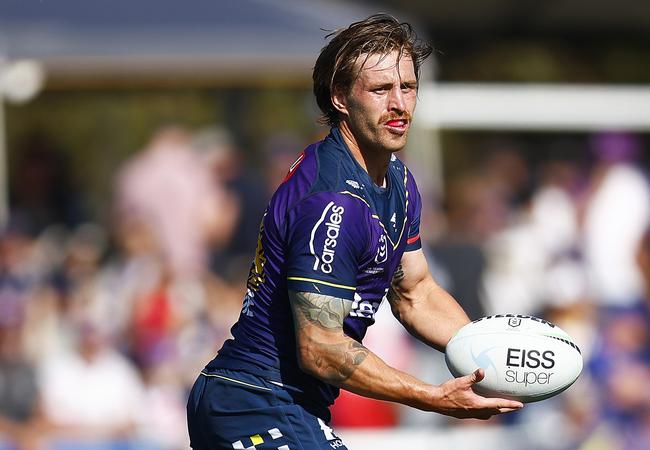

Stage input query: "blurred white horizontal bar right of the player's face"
[{"left": 416, "top": 82, "right": 650, "bottom": 132}]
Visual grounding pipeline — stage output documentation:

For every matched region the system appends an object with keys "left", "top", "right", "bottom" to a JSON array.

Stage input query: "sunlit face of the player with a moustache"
[{"left": 332, "top": 51, "right": 417, "bottom": 152}]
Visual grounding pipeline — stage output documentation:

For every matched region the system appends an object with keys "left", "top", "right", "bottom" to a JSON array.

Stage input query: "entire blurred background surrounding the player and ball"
[{"left": 0, "top": 0, "right": 650, "bottom": 450}]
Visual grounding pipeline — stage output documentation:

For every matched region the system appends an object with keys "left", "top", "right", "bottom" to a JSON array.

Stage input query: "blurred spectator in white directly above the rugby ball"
[{"left": 484, "top": 153, "right": 586, "bottom": 315}]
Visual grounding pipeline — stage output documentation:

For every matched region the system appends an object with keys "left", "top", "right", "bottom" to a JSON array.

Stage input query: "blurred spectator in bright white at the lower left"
[{"left": 39, "top": 321, "right": 144, "bottom": 441}]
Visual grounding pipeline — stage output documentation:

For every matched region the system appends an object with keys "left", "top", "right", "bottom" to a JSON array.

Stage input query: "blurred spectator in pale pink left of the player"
[{"left": 116, "top": 128, "right": 237, "bottom": 278}]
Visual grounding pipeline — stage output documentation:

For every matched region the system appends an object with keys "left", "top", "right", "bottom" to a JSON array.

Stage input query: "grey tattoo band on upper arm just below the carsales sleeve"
[{"left": 289, "top": 292, "right": 352, "bottom": 330}]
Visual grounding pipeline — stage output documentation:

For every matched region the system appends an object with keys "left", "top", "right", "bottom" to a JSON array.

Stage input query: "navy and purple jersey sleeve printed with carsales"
[{"left": 286, "top": 192, "right": 368, "bottom": 300}]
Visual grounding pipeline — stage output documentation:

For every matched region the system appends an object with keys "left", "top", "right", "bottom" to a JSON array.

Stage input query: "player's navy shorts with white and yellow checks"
[{"left": 187, "top": 369, "right": 347, "bottom": 450}]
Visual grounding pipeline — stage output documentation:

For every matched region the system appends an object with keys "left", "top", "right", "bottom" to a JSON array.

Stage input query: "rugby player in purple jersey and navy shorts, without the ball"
[{"left": 188, "top": 15, "right": 523, "bottom": 450}]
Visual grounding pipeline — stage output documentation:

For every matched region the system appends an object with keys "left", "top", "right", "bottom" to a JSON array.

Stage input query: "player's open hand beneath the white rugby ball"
[{"left": 432, "top": 369, "right": 524, "bottom": 420}]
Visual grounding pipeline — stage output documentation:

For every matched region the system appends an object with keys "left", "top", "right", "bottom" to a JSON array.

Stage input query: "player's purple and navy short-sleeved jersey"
[{"left": 208, "top": 128, "right": 421, "bottom": 412}]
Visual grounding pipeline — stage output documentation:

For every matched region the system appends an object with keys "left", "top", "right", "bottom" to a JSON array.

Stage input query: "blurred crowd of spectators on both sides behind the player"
[{"left": 0, "top": 127, "right": 650, "bottom": 450}]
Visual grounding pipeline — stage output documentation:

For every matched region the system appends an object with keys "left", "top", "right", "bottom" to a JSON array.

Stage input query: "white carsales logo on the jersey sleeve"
[{"left": 309, "top": 202, "right": 345, "bottom": 273}]
